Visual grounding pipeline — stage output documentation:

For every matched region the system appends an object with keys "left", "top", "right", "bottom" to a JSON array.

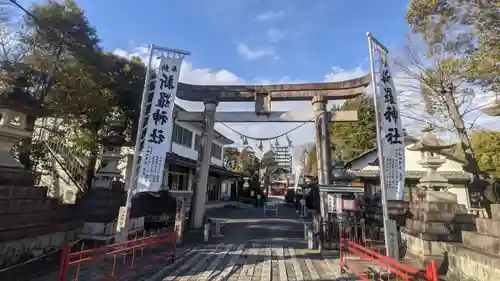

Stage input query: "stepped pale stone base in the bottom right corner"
[{"left": 447, "top": 204, "right": 500, "bottom": 281}]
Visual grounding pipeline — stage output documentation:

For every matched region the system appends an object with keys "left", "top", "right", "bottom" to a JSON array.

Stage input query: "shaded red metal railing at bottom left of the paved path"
[{"left": 58, "top": 232, "right": 177, "bottom": 281}]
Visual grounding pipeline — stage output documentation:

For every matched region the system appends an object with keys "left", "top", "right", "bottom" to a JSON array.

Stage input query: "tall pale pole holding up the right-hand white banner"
[{"left": 366, "top": 32, "right": 392, "bottom": 258}]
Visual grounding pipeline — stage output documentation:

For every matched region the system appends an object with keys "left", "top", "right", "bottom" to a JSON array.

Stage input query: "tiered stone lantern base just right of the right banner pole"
[{"left": 401, "top": 190, "right": 476, "bottom": 263}]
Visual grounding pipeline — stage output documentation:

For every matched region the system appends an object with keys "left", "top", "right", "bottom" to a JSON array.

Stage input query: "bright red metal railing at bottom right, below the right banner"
[{"left": 340, "top": 234, "right": 439, "bottom": 281}]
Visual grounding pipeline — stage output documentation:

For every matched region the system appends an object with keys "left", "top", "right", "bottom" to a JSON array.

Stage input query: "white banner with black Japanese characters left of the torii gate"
[{"left": 134, "top": 53, "right": 184, "bottom": 193}]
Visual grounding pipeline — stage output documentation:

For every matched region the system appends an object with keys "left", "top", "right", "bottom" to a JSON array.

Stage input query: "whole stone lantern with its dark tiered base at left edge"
[{"left": 0, "top": 87, "right": 82, "bottom": 280}]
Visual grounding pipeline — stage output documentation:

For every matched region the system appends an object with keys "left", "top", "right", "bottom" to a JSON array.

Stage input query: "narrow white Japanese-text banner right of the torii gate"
[{"left": 376, "top": 48, "right": 405, "bottom": 200}]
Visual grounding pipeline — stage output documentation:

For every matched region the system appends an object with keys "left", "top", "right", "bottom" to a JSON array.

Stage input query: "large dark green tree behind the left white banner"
[{"left": 0, "top": 0, "right": 145, "bottom": 173}]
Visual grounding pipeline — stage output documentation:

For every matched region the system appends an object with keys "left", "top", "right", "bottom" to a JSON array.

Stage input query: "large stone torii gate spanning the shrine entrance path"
[{"left": 176, "top": 74, "right": 371, "bottom": 228}]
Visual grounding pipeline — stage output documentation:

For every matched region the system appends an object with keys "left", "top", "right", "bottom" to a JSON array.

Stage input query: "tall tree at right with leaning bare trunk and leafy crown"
[{"left": 406, "top": 0, "right": 500, "bottom": 179}]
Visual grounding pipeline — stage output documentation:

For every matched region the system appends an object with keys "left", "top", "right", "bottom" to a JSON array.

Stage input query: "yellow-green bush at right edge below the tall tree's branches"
[{"left": 471, "top": 131, "right": 500, "bottom": 178}]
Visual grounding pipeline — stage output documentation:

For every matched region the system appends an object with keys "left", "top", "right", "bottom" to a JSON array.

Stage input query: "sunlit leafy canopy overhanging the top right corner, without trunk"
[{"left": 406, "top": 0, "right": 500, "bottom": 92}]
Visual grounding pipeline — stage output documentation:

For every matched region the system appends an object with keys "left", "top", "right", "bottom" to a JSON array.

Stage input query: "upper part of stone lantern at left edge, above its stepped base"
[{"left": 0, "top": 87, "right": 42, "bottom": 185}]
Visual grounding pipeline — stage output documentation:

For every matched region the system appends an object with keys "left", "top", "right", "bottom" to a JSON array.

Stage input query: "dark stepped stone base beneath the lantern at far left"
[{"left": 0, "top": 186, "right": 83, "bottom": 272}]
